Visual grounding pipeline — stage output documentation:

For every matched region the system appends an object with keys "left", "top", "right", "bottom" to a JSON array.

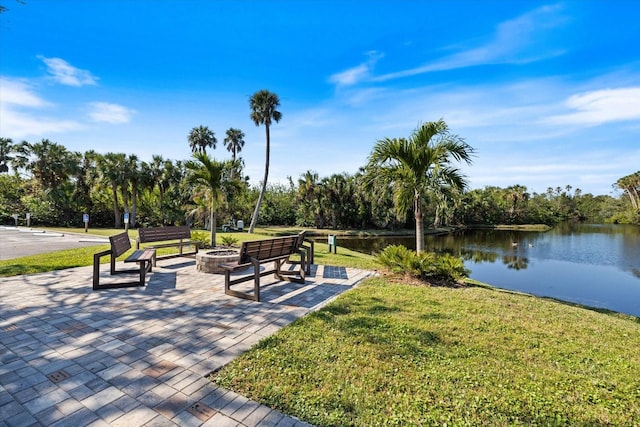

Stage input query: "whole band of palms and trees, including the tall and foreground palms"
[{"left": 0, "top": 118, "right": 640, "bottom": 242}]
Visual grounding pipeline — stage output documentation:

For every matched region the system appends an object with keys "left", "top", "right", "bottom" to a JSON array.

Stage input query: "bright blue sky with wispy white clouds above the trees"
[{"left": 0, "top": 0, "right": 640, "bottom": 194}]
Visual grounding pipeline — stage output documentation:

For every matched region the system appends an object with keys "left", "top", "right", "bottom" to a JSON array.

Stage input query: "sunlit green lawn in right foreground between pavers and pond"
[{"left": 214, "top": 278, "right": 640, "bottom": 426}]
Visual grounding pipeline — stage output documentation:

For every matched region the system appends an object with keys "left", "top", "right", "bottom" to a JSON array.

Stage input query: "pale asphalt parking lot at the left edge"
[{"left": 0, "top": 226, "right": 109, "bottom": 260}]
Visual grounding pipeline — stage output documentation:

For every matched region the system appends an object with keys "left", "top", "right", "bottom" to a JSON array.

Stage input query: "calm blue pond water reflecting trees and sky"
[{"left": 328, "top": 224, "right": 640, "bottom": 316}]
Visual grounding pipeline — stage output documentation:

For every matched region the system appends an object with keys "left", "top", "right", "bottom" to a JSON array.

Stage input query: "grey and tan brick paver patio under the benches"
[{"left": 0, "top": 258, "right": 374, "bottom": 427}]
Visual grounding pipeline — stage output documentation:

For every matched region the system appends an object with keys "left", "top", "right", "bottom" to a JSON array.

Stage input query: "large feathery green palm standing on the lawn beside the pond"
[{"left": 367, "top": 119, "right": 473, "bottom": 253}]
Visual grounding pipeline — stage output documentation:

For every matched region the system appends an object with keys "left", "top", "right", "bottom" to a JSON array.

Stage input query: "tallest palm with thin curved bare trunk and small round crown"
[{"left": 249, "top": 89, "right": 282, "bottom": 233}]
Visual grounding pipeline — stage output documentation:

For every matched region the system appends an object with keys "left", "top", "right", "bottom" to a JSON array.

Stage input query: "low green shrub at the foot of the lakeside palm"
[{"left": 378, "top": 245, "right": 469, "bottom": 281}]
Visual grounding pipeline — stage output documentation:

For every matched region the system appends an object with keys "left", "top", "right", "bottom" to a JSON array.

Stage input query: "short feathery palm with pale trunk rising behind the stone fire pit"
[{"left": 185, "top": 153, "right": 232, "bottom": 247}]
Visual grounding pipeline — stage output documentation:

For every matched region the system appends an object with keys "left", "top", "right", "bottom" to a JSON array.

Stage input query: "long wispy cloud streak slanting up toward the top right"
[{"left": 372, "top": 5, "right": 564, "bottom": 81}]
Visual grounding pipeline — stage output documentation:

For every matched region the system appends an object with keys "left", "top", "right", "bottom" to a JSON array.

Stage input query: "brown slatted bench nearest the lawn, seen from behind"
[{"left": 221, "top": 235, "right": 306, "bottom": 302}]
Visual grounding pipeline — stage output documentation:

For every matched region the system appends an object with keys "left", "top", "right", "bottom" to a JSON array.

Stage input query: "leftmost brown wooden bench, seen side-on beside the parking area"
[{"left": 93, "top": 232, "right": 156, "bottom": 291}]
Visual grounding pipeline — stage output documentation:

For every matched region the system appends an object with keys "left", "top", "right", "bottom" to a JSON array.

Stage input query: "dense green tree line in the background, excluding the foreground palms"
[{"left": 0, "top": 136, "right": 640, "bottom": 229}]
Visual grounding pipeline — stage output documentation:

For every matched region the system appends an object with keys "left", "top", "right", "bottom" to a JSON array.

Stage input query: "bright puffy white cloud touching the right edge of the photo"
[{"left": 545, "top": 87, "right": 640, "bottom": 126}]
